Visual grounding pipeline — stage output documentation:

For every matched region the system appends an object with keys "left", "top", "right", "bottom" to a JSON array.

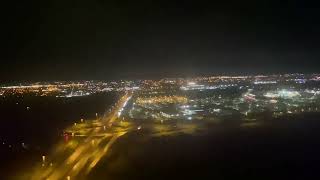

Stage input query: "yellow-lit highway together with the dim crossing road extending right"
[{"left": 23, "top": 92, "right": 199, "bottom": 180}]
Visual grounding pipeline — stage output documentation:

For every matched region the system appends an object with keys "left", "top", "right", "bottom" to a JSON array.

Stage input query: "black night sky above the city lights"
[{"left": 0, "top": 0, "right": 320, "bottom": 82}]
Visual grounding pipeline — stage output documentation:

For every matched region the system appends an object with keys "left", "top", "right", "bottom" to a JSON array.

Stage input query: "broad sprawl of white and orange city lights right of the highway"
[{"left": 122, "top": 74, "right": 320, "bottom": 121}]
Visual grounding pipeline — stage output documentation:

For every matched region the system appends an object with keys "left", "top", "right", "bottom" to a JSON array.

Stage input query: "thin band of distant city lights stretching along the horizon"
[{"left": 0, "top": 73, "right": 320, "bottom": 102}]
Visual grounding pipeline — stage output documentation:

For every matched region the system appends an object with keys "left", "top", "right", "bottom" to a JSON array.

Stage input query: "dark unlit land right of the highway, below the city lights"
[{"left": 89, "top": 114, "right": 320, "bottom": 180}]
